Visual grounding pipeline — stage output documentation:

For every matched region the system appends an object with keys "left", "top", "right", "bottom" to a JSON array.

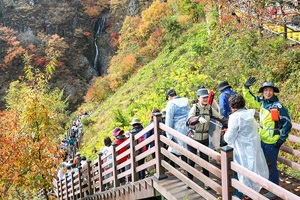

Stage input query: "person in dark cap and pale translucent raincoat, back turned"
[{"left": 165, "top": 89, "right": 190, "bottom": 167}]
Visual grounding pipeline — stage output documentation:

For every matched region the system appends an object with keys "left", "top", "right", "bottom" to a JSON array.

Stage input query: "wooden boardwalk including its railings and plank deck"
[{"left": 56, "top": 116, "right": 300, "bottom": 200}]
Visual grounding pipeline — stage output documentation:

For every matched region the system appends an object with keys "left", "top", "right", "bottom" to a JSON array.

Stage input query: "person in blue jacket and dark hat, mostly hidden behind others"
[{"left": 218, "top": 81, "right": 237, "bottom": 118}]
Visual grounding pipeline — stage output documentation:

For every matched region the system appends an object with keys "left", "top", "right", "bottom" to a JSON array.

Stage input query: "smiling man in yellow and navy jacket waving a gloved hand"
[{"left": 243, "top": 77, "right": 292, "bottom": 199}]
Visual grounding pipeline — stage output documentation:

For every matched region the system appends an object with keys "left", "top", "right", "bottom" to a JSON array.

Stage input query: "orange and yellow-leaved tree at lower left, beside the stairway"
[{"left": 0, "top": 54, "right": 67, "bottom": 198}]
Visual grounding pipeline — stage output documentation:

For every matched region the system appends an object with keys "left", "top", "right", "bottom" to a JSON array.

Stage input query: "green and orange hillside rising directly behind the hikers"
[{"left": 73, "top": 0, "right": 300, "bottom": 159}]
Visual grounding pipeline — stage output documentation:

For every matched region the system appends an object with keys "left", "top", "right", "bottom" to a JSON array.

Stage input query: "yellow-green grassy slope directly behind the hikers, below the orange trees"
[{"left": 80, "top": 24, "right": 300, "bottom": 183}]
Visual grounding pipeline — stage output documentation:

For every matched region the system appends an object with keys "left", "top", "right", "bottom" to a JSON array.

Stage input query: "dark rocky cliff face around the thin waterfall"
[{"left": 0, "top": 0, "right": 152, "bottom": 109}]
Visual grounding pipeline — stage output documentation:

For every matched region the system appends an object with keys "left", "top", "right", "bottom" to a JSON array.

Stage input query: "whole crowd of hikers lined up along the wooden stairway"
[{"left": 59, "top": 77, "right": 292, "bottom": 200}]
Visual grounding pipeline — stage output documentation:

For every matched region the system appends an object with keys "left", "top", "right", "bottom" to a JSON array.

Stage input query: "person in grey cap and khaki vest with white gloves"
[{"left": 187, "top": 88, "right": 227, "bottom": 190}]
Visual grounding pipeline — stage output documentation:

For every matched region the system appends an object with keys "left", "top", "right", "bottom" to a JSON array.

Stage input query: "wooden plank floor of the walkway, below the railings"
[{"left": 83, "top": 170, "right": 300, "bottom": 200}]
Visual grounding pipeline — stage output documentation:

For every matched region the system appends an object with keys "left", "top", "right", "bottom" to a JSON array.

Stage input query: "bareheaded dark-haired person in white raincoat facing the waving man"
[{"left": 224, "top": 94, "right": 269, "bottom": 200}]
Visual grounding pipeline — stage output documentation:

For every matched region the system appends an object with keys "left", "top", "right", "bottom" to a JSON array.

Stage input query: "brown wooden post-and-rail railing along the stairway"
[{"left": 57, "top": 114, "right": 300, "bottom": 200}]
